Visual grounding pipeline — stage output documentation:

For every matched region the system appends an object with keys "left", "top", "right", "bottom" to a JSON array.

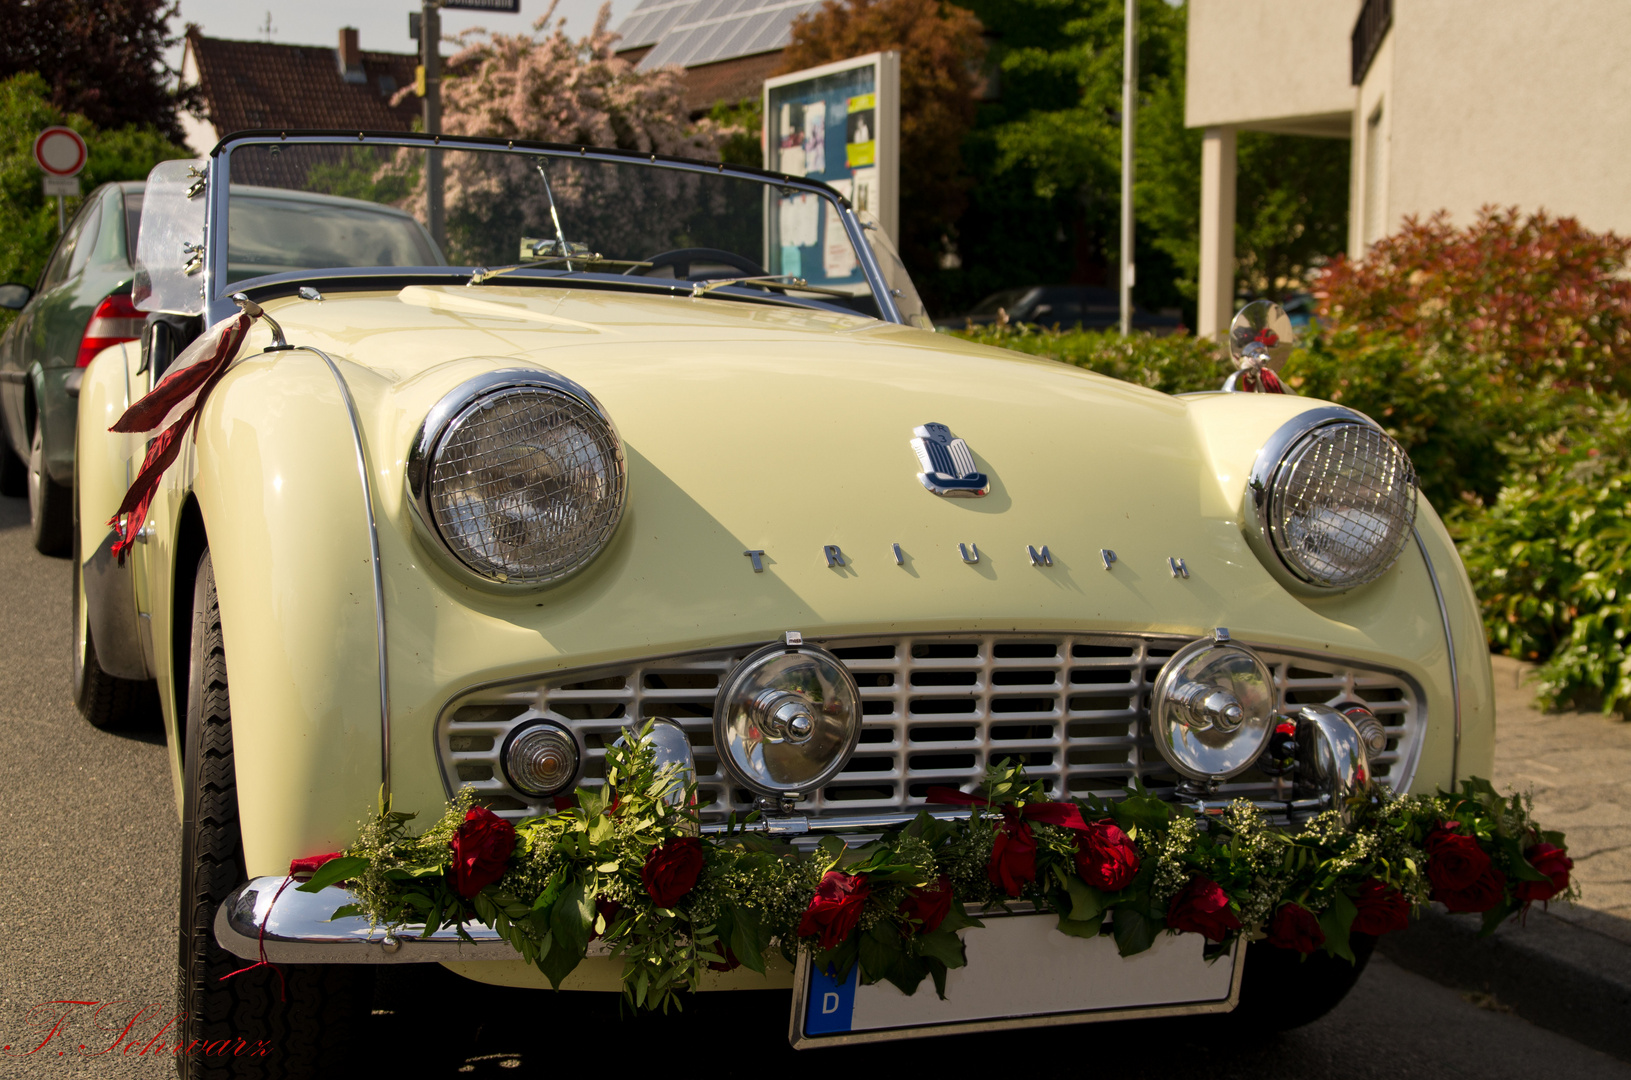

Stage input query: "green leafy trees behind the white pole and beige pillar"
[{"left": 944, "top": 0, "right": 1347, "bottom": 315}]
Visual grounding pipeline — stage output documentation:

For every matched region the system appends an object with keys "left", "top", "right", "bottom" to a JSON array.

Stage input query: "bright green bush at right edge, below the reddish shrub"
[{"left": 1456, "top": 401, "right": 1631, "bottom": 713}]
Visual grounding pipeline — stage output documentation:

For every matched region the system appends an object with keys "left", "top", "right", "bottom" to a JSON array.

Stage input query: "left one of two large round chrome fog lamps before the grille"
[{"left": 714, "top": 643, "right": 861, "bottom": 799}]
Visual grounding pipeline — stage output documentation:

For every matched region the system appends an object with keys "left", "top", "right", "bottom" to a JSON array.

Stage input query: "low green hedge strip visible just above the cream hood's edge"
[{"left": 953, "top": 325, "right": 1233, "bottom": 393}]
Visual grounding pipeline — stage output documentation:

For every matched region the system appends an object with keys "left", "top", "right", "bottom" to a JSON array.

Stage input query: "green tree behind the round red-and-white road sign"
[{"left": 0, "top": 73, "right": 188, "bottom": 326}]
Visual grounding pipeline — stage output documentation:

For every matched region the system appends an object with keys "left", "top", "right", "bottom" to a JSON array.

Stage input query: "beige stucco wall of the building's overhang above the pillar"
[{"left": 1184, "top": 0, "right": 1360, "bottom": 137}]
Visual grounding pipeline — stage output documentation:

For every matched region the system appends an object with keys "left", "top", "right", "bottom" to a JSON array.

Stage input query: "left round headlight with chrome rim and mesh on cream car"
[{"left": 408, "top": 369, "right": 628, "bottom": 586}]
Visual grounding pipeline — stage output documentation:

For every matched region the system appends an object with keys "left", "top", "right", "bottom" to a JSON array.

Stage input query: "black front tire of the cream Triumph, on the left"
[{"left": 176, "top": 551, "right": 373, "bottom": 1080}]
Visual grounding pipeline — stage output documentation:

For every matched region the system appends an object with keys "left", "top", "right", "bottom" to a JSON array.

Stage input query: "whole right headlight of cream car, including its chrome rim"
[{"left": 1244, "top": 406, "right": 1416, "bottom": 591}]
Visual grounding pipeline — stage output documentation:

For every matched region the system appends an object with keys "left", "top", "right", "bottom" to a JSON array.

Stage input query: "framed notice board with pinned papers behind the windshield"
[{"left": 763, "top": 52, "right": 900, "bottom": 289}]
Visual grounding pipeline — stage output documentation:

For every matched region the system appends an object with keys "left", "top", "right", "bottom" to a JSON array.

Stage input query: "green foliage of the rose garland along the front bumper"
[{"left": 327, "top": 753, "right": 1572, "bottom": 1008}]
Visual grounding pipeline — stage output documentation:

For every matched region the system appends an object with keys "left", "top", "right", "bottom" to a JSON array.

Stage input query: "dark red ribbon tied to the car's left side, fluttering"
[{"left": 108, "top": 312, "right": 254, "bottom": 566}]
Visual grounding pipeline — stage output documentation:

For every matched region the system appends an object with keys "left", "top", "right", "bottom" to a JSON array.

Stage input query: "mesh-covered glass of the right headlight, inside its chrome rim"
[{"left": 1266, "top": 421, "right": 1416, "bottom": 589}]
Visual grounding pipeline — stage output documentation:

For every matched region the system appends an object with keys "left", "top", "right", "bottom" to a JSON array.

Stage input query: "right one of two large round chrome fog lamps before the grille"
[{"left": 1150, "top": 630, "right": 1274, "bottom": 783}]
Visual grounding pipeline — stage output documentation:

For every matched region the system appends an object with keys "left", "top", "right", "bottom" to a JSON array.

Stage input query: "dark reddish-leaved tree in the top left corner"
[{"left": 0, "top": 0, "right": 192, "bottom": 142}]
